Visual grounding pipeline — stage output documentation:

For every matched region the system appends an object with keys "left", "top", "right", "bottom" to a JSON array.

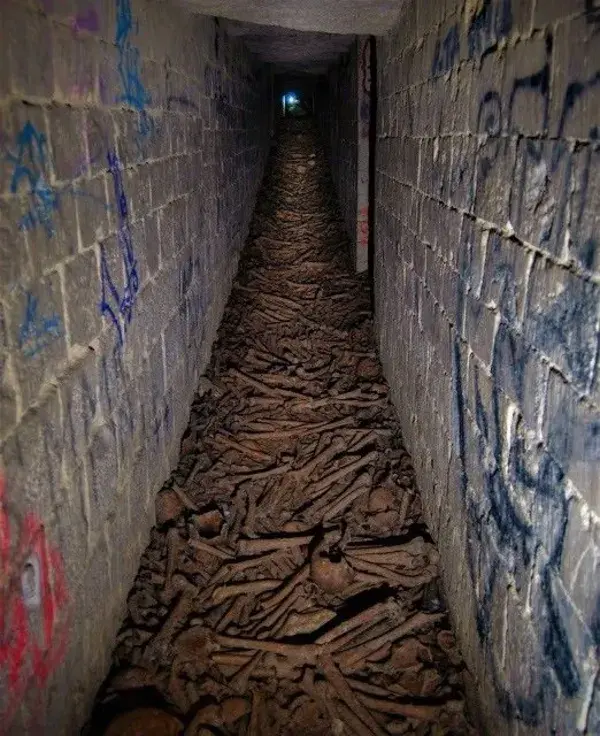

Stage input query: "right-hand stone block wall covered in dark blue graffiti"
[{"left": 375, "top": 0, "right": 600, "bottom": 735}]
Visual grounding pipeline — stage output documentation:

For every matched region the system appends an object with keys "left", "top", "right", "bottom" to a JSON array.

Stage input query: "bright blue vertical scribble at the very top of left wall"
[{"left": 115, "top": 0, "right": 152, "bottom": 138}]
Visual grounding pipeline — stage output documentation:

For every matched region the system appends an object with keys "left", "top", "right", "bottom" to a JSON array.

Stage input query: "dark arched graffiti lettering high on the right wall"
[{"left": 473, "top": 47, "right": 600, "bottom": 288}]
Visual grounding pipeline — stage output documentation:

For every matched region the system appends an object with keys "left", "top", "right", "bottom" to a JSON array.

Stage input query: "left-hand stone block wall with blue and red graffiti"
[{"left": 0, "top": 0, "right": 271, "bottom": 733}]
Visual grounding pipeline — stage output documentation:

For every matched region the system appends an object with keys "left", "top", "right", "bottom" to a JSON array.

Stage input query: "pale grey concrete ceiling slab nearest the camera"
[{"left": 180, "top": 0, "right": 403, "bottom": 35}]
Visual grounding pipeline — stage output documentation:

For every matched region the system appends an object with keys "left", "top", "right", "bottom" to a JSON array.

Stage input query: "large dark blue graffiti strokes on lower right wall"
[{"left": 453, "top": 298, "right": 600, "bottom": 725}]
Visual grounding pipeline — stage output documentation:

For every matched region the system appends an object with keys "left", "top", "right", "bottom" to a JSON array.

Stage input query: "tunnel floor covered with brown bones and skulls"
[{"left": 92, "top": 121, "right": 471, "bottom": 736}]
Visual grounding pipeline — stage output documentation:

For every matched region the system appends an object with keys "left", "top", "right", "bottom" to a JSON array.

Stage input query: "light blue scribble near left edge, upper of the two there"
[{"left": 6, "top": 121, "right": 59, "bottom": 238}]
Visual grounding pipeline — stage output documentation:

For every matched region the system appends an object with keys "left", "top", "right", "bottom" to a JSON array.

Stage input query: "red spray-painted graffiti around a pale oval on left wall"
[{"left": 0, "top": 475, "right": 68, "bottom": 733}]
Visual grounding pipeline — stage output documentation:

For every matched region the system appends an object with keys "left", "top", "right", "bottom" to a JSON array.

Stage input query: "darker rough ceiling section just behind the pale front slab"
[{"left": 224, "top": 21, "right": 354, "bottom": 74}]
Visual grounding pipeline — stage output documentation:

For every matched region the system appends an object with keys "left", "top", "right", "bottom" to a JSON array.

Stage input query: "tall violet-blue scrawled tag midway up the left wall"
[{"left": 100, "top": 151, "right": 140, "bottom": 347}]
